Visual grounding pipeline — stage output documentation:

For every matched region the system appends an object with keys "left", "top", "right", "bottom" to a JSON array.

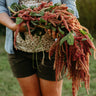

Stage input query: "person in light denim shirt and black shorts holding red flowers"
[{"left": 0, "top": 0, "right": 79, "bottom": 96}]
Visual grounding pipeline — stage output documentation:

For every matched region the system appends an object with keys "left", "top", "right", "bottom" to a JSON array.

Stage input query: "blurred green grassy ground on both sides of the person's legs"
[{"left": 0, "top": 36, "right": 96, "bottom": 96}]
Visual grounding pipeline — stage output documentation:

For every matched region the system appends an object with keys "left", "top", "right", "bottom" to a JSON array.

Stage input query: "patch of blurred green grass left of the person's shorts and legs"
[{"left": 0, "top": 36, "right": 21, "bottom": 96}]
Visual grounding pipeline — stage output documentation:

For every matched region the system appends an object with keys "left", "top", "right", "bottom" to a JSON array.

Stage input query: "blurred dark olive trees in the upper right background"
[{"left": 77, "top": 0, "right": 96, "bottom": 38}]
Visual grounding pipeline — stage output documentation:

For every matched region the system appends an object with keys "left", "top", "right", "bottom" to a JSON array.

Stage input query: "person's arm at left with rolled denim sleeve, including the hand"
[{"left": 0, "top": 0, "right": 25, "bottom": 32}]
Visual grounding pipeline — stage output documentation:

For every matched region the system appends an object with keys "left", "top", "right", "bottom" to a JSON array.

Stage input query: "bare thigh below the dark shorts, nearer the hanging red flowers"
[{"left": 40, "top": 78, "right": 63, "bottom": 96}]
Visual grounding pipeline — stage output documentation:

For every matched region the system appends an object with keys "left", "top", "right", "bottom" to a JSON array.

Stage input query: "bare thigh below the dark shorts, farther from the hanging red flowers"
[{"left": 17, "top": 74, "right": 41, "bottom": 96}]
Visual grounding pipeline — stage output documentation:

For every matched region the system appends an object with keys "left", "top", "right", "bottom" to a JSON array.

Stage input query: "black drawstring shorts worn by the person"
[{"left": 8, "top": 51, "right": 63, "bottom": 81}]
